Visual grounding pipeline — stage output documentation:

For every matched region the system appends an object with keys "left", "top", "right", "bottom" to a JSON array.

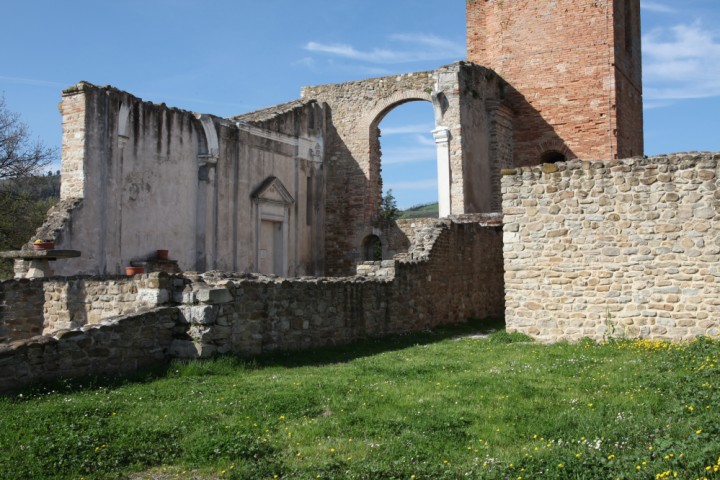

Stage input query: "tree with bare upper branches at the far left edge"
[{"left": 0, "top": 97, "right": 60, "bottom": 278}]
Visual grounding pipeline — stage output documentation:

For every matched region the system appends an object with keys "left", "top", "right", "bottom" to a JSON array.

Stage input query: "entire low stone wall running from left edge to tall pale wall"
[{"left": 0, "top": 217, "right": 503, "bottom": 392}]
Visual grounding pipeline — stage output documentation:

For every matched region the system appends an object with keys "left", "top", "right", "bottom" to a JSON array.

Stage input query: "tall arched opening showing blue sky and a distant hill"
[{"left": 376, "top": 100, "right": 438, "bottom": 218}]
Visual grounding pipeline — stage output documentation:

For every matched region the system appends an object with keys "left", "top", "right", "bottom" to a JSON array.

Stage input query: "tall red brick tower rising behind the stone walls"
[{"left": 467, "top": 0, "right": 643, "bottom": 165}]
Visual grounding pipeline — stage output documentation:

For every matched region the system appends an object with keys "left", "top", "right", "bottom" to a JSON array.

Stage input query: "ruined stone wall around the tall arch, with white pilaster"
[{"left": 302, "top": 62, "right": 512, "bottom": 275}]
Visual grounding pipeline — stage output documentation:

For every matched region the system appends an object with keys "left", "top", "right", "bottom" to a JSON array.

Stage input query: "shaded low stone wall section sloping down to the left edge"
[{"left": 0, "top": 307, "right": 178, "bottom": 392}]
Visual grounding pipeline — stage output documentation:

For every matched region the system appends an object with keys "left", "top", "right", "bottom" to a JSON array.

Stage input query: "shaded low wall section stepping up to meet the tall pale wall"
[{"left": 174, "top": 216, "right": 504, "bottom": 357}]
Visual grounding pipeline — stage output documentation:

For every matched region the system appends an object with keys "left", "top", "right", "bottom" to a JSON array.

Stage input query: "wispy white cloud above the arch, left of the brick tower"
[{"left": 304, "top": 34, "right": 465, "bottom": 64}]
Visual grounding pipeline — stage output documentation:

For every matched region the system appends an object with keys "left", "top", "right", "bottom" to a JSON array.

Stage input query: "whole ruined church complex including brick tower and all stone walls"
[{"left": 5, "top": 0, "right": 720, "bottom": 391}]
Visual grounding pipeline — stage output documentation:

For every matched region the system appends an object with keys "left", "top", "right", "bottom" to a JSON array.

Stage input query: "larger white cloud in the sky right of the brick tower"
[{"left": 643, "top": 22, "right": 720, "bottom": 101}]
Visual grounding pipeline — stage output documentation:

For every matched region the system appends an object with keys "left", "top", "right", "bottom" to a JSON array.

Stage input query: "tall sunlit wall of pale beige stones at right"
[{"left": 502, "top": 153, "right": 720, "bottom": 341}]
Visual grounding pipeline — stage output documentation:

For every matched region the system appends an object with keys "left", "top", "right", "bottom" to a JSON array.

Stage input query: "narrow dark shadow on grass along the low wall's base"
[{"left": 11, "top": 318, "right": 505, "bottom": 401}]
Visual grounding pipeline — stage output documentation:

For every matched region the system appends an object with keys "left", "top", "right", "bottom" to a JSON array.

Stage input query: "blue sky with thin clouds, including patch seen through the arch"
[{"left": 0, "top": 0, "right": 720, "bottom": 207}]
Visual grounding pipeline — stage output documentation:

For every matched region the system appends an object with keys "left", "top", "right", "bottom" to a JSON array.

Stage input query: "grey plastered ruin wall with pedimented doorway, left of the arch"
[{"left": 43, "top": 82, "right": 325, "bottom": 275}]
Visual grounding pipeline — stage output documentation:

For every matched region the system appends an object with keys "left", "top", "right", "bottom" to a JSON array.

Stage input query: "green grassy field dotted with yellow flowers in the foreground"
[{"left": 0, "top": 322, "right": 720, "bottom": 479}]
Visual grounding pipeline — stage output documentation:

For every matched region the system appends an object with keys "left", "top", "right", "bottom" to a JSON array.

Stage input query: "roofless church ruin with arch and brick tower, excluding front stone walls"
[{"left": 40, "top": 0, "right": 643, "bottom": 277}]
